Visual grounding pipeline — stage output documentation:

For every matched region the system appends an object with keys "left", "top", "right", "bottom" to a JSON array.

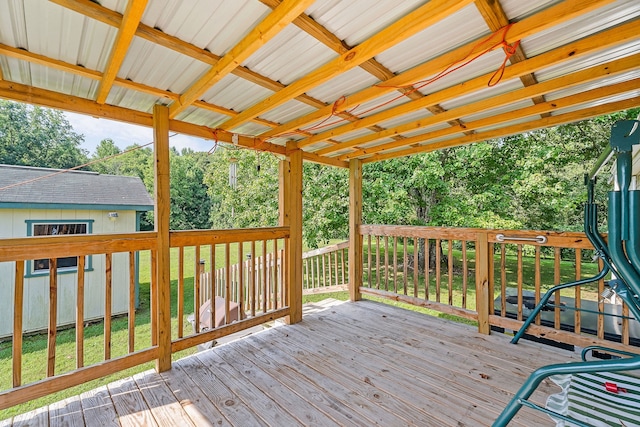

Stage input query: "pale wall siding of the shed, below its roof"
[{"left": 0, "top": 209, "right": 136, "bottom": 337}]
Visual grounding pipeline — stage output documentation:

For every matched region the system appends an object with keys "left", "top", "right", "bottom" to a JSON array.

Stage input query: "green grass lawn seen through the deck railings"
[{"left": 0, "top": 242, "right": 597, "bottom": 420}]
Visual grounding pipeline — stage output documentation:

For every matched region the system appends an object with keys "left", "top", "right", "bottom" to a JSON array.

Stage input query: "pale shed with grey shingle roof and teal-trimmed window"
[{"left": 0, "top": 165, "right": 153, "bottom": 337}]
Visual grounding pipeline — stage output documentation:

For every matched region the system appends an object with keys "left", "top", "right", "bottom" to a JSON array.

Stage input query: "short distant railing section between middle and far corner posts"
[{"left": 302, "top": 241, "right": 349, "bottom": 294}]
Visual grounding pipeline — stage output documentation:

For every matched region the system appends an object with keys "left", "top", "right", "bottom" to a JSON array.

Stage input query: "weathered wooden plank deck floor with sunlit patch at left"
[{"left": 0, "top": 301, "right": 577, "bottom": 427}]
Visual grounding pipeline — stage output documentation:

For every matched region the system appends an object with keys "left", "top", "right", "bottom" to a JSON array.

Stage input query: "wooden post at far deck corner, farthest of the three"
[{"left": 349, "top": 159, "right": 363, "bottom": 301}]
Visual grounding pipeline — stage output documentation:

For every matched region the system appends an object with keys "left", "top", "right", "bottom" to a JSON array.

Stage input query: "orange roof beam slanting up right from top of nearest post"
[{"left": 169, "top": 0, "right": 313, "bottom": 118}]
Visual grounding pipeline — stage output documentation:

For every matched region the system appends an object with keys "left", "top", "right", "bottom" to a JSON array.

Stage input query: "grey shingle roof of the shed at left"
[{"left": 0, "top": 165, "right": 153, "bottom": 211}]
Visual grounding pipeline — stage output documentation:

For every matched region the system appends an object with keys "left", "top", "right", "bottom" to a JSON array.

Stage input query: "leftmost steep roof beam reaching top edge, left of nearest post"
[{"left": 96, "top": 0, "right": 147, "bottom": 104}]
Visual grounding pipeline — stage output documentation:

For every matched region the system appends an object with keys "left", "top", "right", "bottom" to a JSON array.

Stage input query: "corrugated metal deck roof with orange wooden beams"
[{"left": 0, "top": 0, "right": 640, "bottom": 166}]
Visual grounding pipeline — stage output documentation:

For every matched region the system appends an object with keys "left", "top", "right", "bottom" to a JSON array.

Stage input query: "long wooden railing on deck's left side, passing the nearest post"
[{"left": 0, "top": 227, "right": 289, "bottom": 409}]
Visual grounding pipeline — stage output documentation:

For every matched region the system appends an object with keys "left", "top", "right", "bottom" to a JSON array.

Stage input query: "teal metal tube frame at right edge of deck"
[{"left": 493, "top": 120, "right": 640, "bottom": 427}]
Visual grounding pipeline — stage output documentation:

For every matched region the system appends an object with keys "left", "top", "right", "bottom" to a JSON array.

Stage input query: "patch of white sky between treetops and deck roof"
[{"left": 64, "top": 112, "right": 213, "bottom": 155}]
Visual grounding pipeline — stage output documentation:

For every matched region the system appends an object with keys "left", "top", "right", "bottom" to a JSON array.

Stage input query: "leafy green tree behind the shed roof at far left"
[{"left": 0, "top": 100, "right": 87, "bottom": 169}]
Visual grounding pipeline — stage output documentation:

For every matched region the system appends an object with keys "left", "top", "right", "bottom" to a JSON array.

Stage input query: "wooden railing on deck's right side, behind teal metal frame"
[{"left": 360, "top": 225, "right": 640, "bottom": 349}]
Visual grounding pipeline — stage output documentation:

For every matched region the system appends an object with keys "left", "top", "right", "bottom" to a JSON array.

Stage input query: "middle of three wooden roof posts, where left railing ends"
[{"left": 280, "top": 142, "right": 302, "bottom": 323}]
